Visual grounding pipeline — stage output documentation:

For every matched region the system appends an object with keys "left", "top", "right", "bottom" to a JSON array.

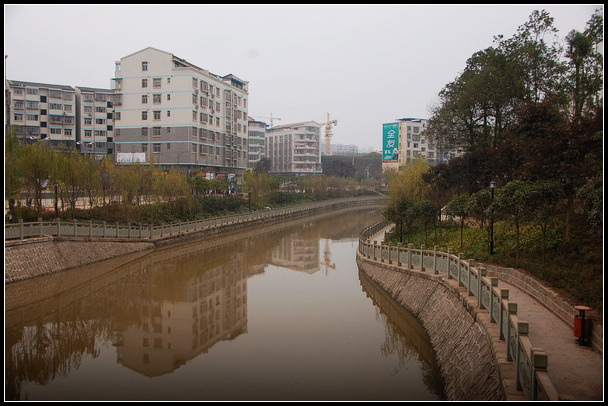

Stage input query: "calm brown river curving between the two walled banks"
[{"left": 5, "top": 209, "right": 445, "bottom": 401}]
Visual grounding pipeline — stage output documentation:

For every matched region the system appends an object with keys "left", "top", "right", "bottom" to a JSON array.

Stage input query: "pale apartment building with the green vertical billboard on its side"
[{"left": 382, "top": 118, "right": 462, "bottom": 171}]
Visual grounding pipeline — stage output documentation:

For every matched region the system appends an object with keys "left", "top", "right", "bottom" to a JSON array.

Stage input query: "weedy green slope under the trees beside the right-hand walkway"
[{"left": 386, "top": 220, "right": 603, "bottom": 314}]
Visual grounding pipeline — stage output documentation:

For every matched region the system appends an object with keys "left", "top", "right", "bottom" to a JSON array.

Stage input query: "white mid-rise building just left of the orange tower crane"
[{"left": 266, "top": 121, "right": 323, "bottom": 175}]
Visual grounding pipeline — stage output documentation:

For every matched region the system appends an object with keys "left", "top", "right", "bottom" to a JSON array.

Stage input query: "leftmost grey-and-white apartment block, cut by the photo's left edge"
[{"left": 5, "top": 80, "right": 76, "bottom": 148}]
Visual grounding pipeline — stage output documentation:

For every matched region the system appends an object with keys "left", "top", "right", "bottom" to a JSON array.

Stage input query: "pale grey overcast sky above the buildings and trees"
[{"left": 4, "top": 4, "right": 603, "bottom": 151}]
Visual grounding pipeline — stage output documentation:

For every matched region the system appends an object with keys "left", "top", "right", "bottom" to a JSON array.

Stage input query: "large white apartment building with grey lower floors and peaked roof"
[{"left": 113, "top": 47, "right": 248, "bottom": 179}]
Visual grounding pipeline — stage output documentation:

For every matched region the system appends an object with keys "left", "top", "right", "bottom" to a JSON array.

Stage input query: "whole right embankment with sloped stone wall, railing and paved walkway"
[{"left": 357, "top": 227, "right": 603, "bottom": 401}]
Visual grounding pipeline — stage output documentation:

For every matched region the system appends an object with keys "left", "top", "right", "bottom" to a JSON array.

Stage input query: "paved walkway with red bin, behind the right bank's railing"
[{"left": 371, "top": 225, "right": 604, "bottom": 402}]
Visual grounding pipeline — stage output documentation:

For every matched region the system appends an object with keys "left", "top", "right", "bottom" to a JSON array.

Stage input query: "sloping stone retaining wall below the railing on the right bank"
[{"left": 357, "top": 255, "right": 507, "bottom": 401}]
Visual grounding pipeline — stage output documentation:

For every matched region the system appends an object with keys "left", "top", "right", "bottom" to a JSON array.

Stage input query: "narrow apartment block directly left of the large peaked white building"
[{"left": 76, "top": 86, "right": 116, "bottom": 160}]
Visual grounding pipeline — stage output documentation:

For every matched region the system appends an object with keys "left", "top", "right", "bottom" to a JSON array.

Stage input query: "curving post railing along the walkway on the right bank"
[{"left": 359, "top": 220, "right": 559, "bottom": 401}]
